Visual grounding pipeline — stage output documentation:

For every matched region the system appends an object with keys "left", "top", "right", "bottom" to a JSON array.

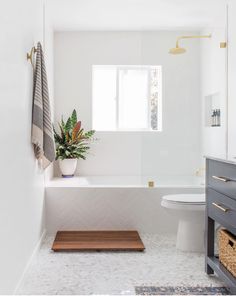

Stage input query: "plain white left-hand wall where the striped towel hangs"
[{"left": 0, "top": 0, "right": 44, "bottom": 294}]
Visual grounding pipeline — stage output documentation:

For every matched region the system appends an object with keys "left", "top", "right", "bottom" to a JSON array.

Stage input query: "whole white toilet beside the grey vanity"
[{"left": 161, "top": 194, "right": 206, "bottom": 252}]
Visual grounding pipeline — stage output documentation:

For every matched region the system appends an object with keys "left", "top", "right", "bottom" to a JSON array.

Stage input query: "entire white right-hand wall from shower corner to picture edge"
[{"left": 201, "top": 0, "right": 236, "bottom": 161}]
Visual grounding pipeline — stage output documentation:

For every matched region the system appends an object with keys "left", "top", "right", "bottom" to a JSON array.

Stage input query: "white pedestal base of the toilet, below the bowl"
[{"left": 176, "top": 217, "right": 205, "bottom": 253}]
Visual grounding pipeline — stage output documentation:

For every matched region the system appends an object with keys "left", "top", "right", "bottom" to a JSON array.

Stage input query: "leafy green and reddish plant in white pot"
[{"left": 53, "top": 110, "right": 95, "bottom": 178}]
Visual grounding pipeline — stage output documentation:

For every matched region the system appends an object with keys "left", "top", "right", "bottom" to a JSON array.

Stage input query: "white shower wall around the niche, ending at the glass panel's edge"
[{"left": 201, "top": 26, "right": 227, "bottom": 162}]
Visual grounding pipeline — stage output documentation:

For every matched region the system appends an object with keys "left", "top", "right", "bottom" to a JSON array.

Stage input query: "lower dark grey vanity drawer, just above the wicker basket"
[{"left": 207, "top": 188, "right": 236, "bottom": 232}]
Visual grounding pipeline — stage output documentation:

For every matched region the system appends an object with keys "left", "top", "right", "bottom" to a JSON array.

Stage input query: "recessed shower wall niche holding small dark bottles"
[{"left": 205, "top": 92, "right": 222, "bottom": 127}]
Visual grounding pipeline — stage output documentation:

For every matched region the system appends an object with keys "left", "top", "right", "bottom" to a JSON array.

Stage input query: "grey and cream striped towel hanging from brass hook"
[{"left": 31, "top": 42, "right": 55, "bottom": 169}]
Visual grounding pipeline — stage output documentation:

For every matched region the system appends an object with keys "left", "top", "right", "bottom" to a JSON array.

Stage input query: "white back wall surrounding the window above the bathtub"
[{"left": 54, "top": 31, "right": 200, "bottom": 175}]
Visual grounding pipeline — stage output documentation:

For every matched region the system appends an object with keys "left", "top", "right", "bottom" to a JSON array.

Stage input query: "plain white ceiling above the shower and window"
[{"left": 45, "top": 0, "right": 229, "bottom": 31}]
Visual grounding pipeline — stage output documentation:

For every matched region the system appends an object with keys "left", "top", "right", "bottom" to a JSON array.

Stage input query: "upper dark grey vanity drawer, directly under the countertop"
[{"left": 206, "top": 160, "right": 236, "bottom": 199}]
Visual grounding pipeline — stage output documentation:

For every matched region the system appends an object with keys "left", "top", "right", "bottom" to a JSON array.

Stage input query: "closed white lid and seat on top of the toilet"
[{"left": 162, "top": 194, "right": 206, "bottom": 204}]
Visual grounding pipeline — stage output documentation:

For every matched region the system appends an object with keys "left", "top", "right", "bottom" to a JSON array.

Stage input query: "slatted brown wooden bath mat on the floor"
[{"left": 52, "top": 231, "right": 145, "bottom": 251}]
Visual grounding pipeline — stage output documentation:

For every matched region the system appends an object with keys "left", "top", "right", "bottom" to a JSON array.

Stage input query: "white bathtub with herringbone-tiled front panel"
[{"left": 46, "top": 176, "right": 204, "bottom": 234}]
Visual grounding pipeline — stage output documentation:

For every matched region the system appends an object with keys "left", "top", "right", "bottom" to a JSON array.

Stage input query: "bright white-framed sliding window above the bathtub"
[{"left": 92, "top": 65, "right": 162, "bottom": 131}]
